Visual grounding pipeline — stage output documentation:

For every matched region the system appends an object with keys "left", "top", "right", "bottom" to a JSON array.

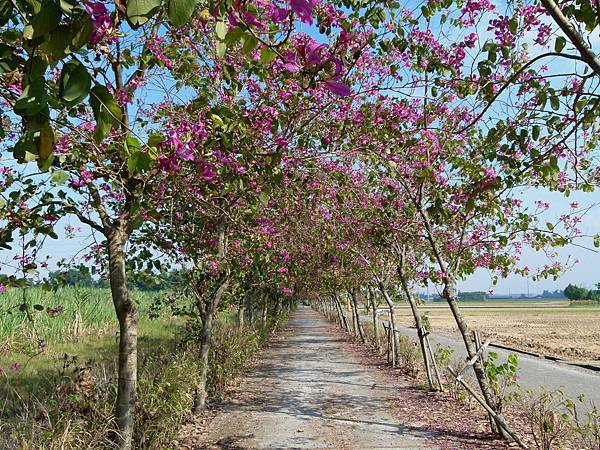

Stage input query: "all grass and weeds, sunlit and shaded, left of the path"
[{"left": 0, "top": 288, "right": 288, "bottom": 450}]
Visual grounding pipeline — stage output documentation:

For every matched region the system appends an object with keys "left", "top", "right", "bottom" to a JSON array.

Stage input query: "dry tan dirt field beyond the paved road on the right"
[{"left": 397, "top": 300, "right": 600, "bottom": 361}]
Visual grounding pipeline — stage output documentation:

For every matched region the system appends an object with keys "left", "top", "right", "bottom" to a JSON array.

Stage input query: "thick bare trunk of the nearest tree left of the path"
[{"left": 107, "top": 229, "right": 138, "bottom": 450}]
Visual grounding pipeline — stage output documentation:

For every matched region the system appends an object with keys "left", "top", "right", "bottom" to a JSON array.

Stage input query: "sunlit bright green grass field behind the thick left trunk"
[{"left": 0, "top": 287, "right": 177, "bottom": 417}]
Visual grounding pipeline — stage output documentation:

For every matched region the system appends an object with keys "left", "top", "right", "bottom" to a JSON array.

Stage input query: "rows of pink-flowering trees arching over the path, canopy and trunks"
[{"left": 0, "top": 0, "right": 600, "bottom": 448}]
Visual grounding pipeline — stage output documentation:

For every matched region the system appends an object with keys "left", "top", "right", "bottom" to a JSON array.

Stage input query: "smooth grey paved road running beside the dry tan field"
[{"left": 396, "top": 325, "right": 600, "bottom": 406}]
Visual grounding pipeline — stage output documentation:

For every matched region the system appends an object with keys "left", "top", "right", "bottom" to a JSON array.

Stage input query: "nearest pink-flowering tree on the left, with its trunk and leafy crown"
[{"left": 0, "top": 0, "right": 366, "bottom": 442}]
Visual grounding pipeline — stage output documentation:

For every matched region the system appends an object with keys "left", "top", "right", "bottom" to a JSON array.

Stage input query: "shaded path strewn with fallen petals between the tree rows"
[{"left": 198, "top": 307, "right": 433, "bottom": 449}]
